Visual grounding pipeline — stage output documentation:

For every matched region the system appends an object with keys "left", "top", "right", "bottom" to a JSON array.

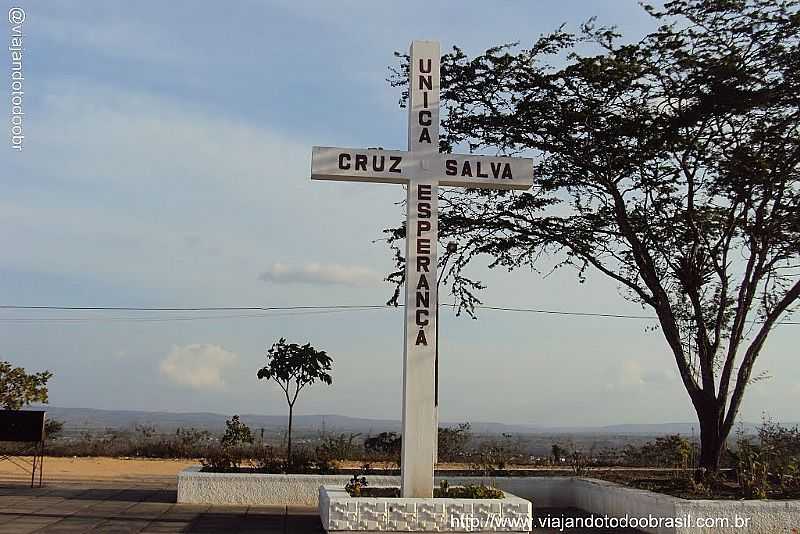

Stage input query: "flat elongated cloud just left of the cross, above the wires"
[{"left": 258, "top": 263, "right": 383, "bottom": 287}]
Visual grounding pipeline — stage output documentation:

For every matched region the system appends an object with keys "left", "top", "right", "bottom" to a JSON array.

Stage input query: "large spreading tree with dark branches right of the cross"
[{"left": 387, "top": 0, "right": 800, "bottom": 478}]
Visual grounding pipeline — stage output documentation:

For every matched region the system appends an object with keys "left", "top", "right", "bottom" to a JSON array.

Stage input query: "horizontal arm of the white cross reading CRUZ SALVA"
[{"left": 311, "top": 146, "right": 533, "bottom": 189}]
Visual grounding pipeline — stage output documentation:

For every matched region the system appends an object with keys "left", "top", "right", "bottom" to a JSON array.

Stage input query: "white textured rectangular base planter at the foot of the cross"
[{"left": 319, "top": 485, "right": 533, "bottom": 534}]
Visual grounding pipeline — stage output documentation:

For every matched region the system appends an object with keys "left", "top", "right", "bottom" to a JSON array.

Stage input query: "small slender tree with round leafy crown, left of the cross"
[{"left": 258, "top": 338, "right": 333, "bottom": 466}]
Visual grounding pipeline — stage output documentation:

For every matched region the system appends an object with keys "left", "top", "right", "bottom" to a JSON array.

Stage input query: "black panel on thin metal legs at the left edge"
[{"left": 0, "top": 410, "right": 47, "bottom": 488}]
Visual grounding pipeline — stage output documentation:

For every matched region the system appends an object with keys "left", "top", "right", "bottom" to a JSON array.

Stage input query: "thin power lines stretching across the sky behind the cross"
[{"left": 0, "top": 304, "right": 800, "bottom": 326}]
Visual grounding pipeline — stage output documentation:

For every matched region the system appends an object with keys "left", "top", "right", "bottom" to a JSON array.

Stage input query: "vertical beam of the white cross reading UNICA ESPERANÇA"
[{"left": 400, "top": 41, "right": 440, "bottom": 497}]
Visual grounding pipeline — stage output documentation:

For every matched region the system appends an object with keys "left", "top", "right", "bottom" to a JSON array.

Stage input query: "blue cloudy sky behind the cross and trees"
[{"left": 0, "top": 0, "right": 800, "bottom": 426}]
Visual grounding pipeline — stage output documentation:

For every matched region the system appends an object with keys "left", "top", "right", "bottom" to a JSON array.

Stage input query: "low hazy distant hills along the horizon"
[{"left": 32, "top": 406, "right": 796, "bottom": 436}]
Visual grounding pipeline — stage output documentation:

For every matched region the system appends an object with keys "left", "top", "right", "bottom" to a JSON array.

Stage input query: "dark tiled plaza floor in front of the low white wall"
[{"left": 0, "top": 478, "right": 635, "bottom": 534}]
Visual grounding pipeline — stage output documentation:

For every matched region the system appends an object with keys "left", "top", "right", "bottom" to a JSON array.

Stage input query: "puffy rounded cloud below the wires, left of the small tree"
[{"left": 159, "top": 343, "right": 239, "bottom": 389}]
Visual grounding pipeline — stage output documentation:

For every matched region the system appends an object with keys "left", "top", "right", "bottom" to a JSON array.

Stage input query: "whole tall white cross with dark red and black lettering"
[{"left": 311, "top": 41, "right": 533, "bottom": 498}]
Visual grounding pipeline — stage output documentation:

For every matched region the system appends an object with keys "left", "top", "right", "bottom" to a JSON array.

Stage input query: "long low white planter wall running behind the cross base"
[{"left": 178, "top": 472, "right": 800, "bottom": 534}]
